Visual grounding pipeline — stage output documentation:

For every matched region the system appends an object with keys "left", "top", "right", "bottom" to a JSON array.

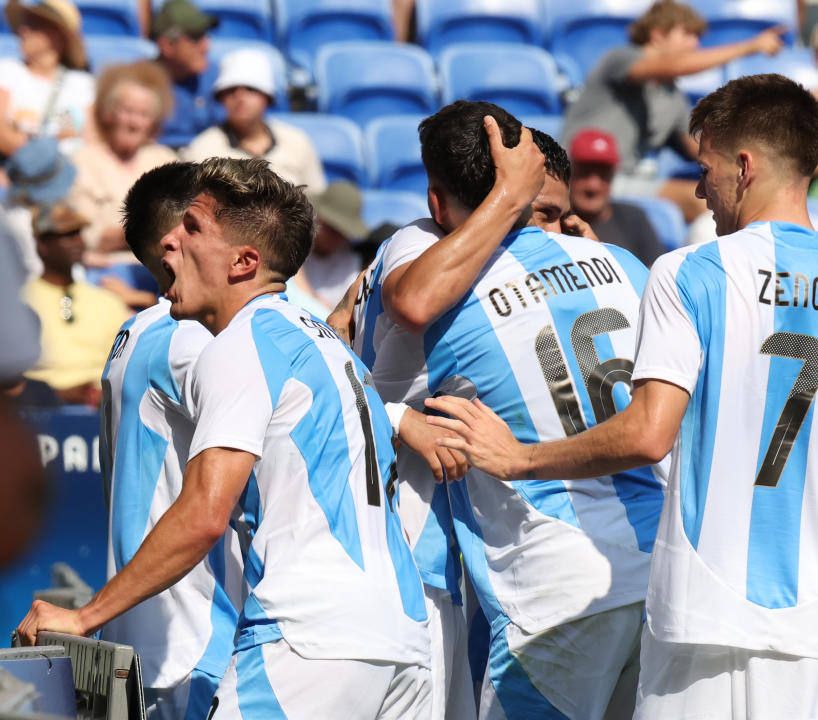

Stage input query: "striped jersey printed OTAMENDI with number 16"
[{"left": 424, "top": 227, "right": 662, "bottom": 633}]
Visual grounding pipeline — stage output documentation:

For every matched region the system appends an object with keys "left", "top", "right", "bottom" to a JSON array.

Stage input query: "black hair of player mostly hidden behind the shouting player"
[{"left": 122, "top": 162, "right": 199, "bottom": 262}]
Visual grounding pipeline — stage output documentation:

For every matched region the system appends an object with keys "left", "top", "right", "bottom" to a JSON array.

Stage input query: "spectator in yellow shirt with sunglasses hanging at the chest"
[{"left": 23, "top": 203, "right": 129, "bottom": 405}]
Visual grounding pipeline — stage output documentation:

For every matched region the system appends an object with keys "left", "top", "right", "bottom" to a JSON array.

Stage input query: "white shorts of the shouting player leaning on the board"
[{"left": 208, "top": 640, "right": 431, "bottom": 720}]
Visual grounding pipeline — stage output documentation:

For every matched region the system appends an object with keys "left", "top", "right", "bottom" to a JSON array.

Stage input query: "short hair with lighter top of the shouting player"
[{"left": 195, "top": 157, "right": 317, "bottom": 278}]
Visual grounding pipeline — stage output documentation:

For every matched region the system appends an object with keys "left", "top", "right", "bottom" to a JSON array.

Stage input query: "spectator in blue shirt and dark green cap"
[{"left": 151, "top": 0, "right": 221, "bottom": 147}]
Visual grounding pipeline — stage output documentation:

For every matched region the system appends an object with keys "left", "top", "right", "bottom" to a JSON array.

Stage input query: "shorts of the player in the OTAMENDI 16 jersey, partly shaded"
[{"left": 480, "top": 603, "right": 644, "bottom": 720}]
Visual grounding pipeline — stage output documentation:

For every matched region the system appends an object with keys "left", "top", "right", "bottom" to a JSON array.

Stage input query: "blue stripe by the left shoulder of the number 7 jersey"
[{"left": 676, "top": 242, "right": 727, "bottom": 549}]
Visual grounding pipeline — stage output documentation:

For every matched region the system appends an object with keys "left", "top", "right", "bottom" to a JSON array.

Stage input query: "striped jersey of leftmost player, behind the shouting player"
[{"left": 100, "top": 300, "right": 242, "bottom": 688}]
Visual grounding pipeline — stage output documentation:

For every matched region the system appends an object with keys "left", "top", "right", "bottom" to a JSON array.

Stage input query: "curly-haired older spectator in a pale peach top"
[{"left": 68, "top": 61, "right": 176, "bottom": 256}]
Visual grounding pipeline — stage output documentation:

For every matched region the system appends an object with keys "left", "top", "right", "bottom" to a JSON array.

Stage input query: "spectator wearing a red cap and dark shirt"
[{"left": 570, "top": 128, "right": 665, "bottom": 267}]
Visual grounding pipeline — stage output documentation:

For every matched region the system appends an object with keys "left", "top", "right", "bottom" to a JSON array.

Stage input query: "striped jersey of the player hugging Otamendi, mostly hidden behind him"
[{"left": 353, "top": 218, "right": 462, "bottom": 604}]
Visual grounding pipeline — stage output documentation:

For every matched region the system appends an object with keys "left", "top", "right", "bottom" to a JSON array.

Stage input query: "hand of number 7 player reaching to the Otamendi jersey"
[{"left": 426, "top": 395, "right": 527, "bottom": 480}]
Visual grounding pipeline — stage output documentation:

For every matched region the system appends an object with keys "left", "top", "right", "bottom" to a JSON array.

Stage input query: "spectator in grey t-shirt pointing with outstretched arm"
[{"left": 562, "top": 0, "right": 785, "bottom": 221}]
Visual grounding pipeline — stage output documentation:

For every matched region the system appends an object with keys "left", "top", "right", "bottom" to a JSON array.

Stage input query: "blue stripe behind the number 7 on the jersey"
[{"left": 747, "top": 223, "right": 818, "bottom": 608}]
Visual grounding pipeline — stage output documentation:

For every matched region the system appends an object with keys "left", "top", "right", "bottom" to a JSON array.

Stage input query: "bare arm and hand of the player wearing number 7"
[{"left": 426, "top": 380, "right": 690, "bottom": 480}]
